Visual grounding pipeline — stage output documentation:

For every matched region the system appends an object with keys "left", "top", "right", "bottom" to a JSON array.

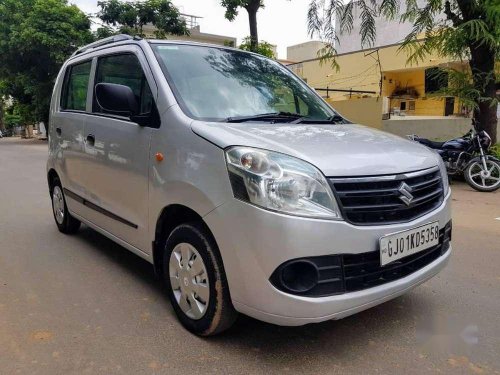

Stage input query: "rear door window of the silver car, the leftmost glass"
[{"left": 61, "top": 61, "right": 92, "bottom": 111}]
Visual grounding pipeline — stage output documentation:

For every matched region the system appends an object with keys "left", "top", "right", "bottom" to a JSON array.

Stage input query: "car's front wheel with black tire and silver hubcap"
[{"left": 163, "top": 222, "right": 238, "bottom": 336}]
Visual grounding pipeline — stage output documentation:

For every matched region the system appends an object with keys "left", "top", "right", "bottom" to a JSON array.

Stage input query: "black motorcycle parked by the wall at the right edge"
[{"left": 408, "top": 120, "right": 500, "bottom": 192}]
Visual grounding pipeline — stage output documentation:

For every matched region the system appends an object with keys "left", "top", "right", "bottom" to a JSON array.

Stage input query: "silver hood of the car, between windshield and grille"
[{"left": 191, "top": 121, "right": 437, "bottom": 177}]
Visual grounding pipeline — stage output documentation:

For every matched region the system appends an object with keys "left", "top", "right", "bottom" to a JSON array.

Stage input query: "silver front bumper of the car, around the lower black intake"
[{"left": 204, "top": 193, "right": 451, "bottom": 325}]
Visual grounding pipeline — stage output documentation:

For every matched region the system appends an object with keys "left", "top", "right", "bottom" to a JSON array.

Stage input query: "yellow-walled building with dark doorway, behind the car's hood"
[{"left": 288, "top": 44, "right": 463, "bottom": 126}]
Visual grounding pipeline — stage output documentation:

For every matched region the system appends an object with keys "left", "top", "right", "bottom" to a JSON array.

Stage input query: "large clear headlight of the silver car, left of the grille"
[{"left": 226, "top": 147, "right": 341, "bottom": 220}]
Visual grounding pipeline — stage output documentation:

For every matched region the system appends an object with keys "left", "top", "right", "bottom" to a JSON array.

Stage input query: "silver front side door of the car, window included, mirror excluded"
[{"left": 82, "top": 46, "right": 157, "bottom": 253}]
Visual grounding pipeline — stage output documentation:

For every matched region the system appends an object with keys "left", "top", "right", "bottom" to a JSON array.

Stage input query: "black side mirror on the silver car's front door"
[{"left": 95, "top": 83, "right": 139, "bottom": 117}]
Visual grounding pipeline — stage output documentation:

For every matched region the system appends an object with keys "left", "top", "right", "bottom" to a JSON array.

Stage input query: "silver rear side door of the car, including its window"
[{"left": 50, "top": 59, "right": 92, "bottom": 213}]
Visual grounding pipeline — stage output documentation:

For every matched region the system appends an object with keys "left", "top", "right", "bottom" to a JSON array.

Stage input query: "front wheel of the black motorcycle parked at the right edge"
[{"left": 464, "top": 160, "right": 500, "bottom": 192}]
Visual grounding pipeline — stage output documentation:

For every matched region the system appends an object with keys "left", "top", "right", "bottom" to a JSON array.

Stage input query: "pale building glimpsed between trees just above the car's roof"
[{"left": 143, "top": 14, "right": 237, "bottom": 47}]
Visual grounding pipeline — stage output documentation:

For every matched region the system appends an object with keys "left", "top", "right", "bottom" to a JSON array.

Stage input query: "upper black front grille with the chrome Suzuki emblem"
[{"left": 329, "top": 167, "right": 444, "bottom": 225}]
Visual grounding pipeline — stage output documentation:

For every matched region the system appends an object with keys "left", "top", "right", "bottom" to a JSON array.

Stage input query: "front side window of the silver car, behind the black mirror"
[{"left": 93, "top": 54, "right": 153, "bottom": 114}]
